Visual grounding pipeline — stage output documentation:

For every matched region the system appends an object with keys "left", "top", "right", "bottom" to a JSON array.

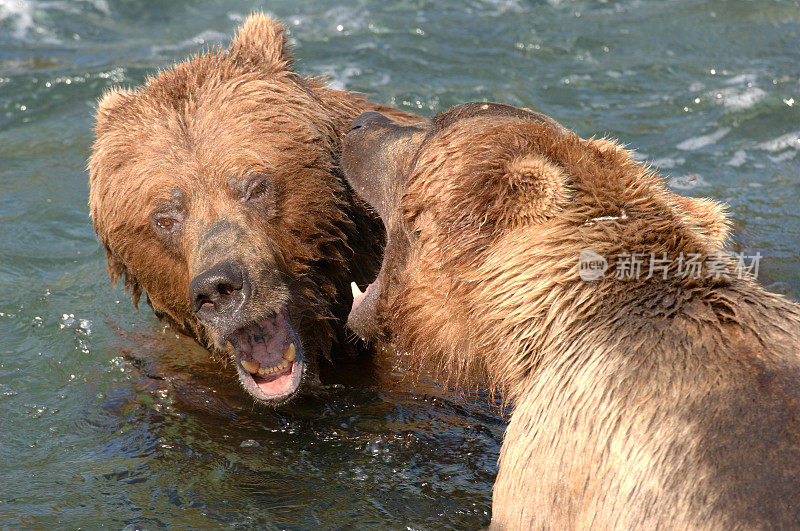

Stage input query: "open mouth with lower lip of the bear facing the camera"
[{"left": 233, "top": 306, "right": 305, "bottom": 404}]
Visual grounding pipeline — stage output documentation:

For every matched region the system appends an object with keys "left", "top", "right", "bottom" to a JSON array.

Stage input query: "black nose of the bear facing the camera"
[{"left": 189, "top": 262, "right": 249, "bottom": 324}]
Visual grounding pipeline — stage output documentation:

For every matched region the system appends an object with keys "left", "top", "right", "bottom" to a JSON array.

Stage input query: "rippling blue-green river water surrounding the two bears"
[{"left": 0, "top": 0, "right": 800, "bottom": 529}]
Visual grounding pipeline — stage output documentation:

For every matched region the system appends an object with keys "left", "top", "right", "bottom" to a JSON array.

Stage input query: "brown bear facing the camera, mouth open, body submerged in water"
[{"left": 88, "top": 14, "right": 419, "bottom": 404}]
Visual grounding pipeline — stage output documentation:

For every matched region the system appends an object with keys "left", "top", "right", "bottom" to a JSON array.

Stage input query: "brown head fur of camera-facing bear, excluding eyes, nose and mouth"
[{"left": 88, "top": 14, "right": 417, "bottom": 384}]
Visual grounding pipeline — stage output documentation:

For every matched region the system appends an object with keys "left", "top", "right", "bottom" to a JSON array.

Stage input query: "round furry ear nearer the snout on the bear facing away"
[{"left": 497, "top": 154, "right": 569, "bottom": 226}]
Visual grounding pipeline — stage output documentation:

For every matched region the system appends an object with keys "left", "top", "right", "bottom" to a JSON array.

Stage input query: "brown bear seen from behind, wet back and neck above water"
[{"left": 342, "top": 103, "right": 800, "bottom": 529}]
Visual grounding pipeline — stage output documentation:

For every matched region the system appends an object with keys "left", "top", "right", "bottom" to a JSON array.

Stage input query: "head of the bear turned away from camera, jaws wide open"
[{"left": 342, "top": 103, "right": 729, "bottom": 394}]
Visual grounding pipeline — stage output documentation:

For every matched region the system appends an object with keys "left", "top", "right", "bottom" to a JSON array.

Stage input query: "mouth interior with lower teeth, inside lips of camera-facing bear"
[{"left": 230, "top": 309, "right": 297, "bottom": 395}]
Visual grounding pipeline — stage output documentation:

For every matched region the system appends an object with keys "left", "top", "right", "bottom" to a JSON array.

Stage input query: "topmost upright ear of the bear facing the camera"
[{"left": 228, "top": 13, "right": 294, "bottom": 72}]
